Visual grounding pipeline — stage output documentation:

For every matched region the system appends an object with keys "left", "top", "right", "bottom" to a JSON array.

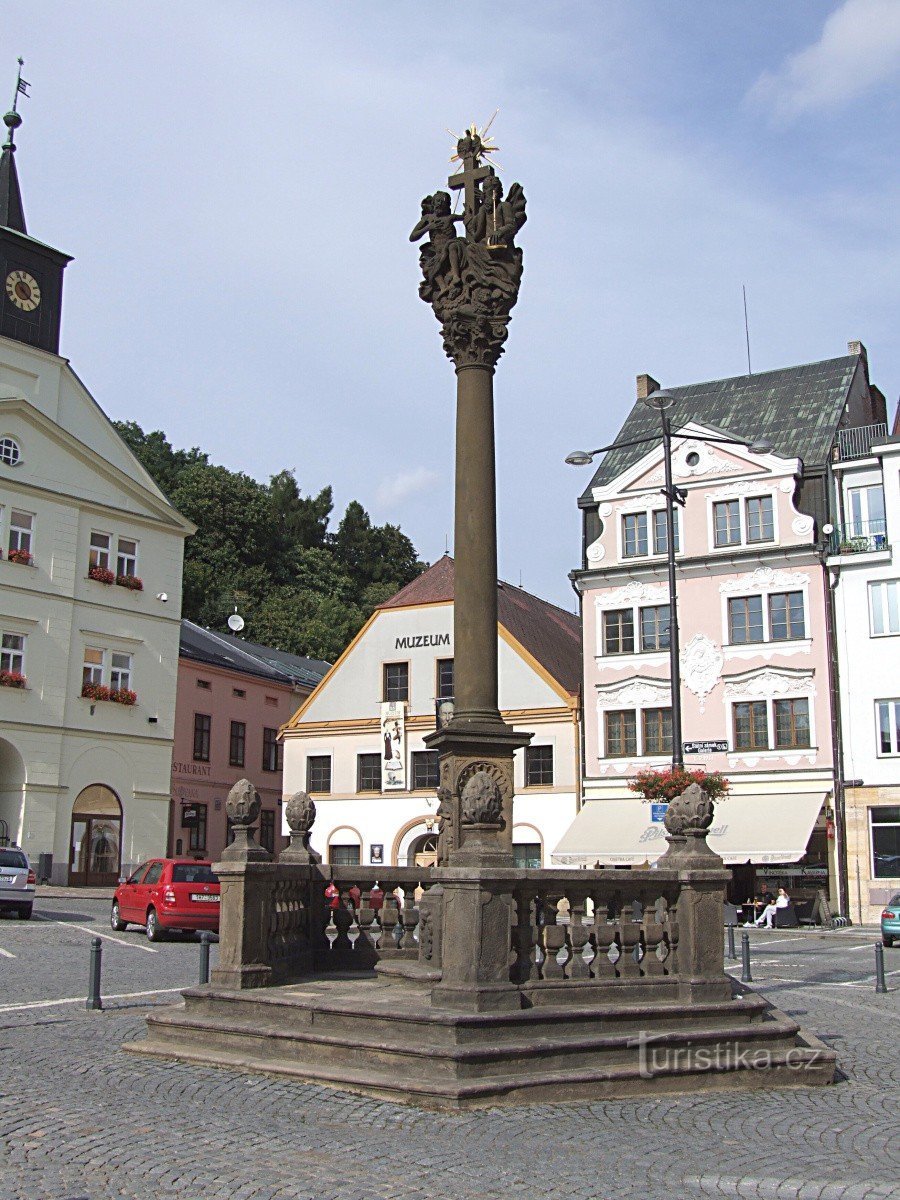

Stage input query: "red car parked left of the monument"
[{"left": 109, "top": 858, "right": 221, "bottom": 942}]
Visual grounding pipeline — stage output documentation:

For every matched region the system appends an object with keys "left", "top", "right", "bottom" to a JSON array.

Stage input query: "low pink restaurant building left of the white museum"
[{"left": 168, "top": 620, "right": 329, "bottom": 860}]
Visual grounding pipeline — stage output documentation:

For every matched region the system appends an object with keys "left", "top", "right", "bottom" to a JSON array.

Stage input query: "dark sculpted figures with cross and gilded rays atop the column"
[{"left": 409, "top": 128, "right": 526, "bottom": 367}]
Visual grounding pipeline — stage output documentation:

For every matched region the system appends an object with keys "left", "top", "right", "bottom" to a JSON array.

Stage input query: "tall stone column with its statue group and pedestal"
[{"left": 410, "top": 127, "right": 532, "bottom": 1008}]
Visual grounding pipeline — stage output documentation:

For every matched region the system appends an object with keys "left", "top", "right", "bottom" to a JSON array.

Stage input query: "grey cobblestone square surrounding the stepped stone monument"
[{"left": 0, "top": 896, "right": 900, "bottom": 1200}]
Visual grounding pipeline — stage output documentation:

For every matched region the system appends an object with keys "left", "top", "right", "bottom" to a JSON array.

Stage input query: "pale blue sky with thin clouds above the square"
[{"left": 8, "top": 0, "right": 900, "bottom": 607}]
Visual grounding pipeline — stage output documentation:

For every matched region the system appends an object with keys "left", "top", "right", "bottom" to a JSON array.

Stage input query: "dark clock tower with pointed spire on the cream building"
[{"left": 0, "top": 86, "right": 72, "bottom": 354}]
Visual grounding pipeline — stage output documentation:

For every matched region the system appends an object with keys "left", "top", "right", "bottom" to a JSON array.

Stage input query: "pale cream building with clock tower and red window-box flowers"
[{"left": 0, "top": 108, "right": 193, "bottom": 883}]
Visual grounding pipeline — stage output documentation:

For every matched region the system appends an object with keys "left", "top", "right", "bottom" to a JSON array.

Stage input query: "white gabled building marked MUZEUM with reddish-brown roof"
[{"left": 282, "top": 556, "right": 581, "bottom": 866}]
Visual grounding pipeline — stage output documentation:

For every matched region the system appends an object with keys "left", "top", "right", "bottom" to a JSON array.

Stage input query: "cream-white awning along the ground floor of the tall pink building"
[{"left": 551, "top": 792, "right": 826, "bottom": 866}]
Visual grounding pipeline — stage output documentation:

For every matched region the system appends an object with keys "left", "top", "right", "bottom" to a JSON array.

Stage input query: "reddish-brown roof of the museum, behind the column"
[{"left": 378, "top": 554, "right": 581, "bottom": 696}]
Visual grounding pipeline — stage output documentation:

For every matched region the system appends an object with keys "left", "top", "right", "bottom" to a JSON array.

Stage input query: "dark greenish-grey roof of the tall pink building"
[{"left": 581, "top": 354, "right": 862, "bottom": 503}]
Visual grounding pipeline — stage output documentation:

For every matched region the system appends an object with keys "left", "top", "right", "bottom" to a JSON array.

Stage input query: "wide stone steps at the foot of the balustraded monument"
[{"left": 124, "top": 962, "right": 835, "bottom": 1109}]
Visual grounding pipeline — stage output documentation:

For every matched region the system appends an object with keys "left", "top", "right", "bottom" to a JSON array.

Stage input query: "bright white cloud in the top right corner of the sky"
[{"left": 746, "top": 0, "right": 900, "bottom": 120}]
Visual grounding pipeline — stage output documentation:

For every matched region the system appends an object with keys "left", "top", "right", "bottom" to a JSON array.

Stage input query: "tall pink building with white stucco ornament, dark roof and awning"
[{"left": 553, "top": 343, "right": 883, "bottom": 901}]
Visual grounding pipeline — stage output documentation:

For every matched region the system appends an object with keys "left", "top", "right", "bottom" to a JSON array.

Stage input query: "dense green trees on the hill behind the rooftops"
[{"left": 115, "top": 421, "right": 425, "bottom": 661}]
